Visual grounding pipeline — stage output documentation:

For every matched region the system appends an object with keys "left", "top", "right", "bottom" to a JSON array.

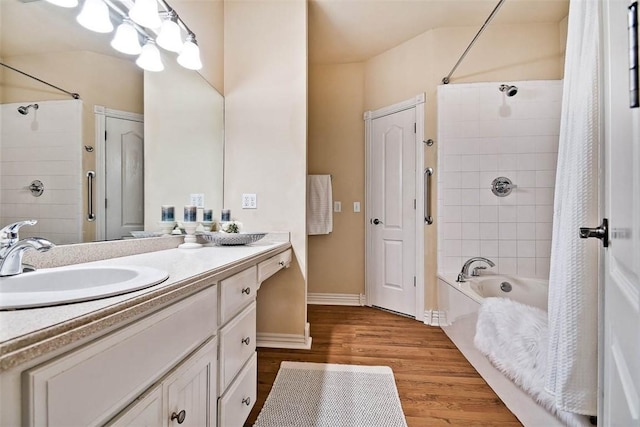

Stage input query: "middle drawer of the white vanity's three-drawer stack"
[{"left": 219, "top": 301, "right": 256, "bottom": 394}]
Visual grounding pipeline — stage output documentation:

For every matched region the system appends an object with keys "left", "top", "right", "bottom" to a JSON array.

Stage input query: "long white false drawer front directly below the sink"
[{"left": 23, "top": 286, "right": 217, "bottom": 426}]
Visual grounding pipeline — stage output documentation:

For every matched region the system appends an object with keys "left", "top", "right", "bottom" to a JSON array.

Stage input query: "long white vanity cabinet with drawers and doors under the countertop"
[{"left": 0, "top": 244, "right": 292, "bottom": 427}]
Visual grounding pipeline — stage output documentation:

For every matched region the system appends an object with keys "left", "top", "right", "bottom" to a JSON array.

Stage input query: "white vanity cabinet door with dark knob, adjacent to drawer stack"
[{"left": 163, "top": 340, "right": 217, "bottom": 427}]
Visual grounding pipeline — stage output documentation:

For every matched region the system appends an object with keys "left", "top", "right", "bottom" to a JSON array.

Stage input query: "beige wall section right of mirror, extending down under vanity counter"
[{"left": 224, "top": 0, "right": 307, "bottom": 335}]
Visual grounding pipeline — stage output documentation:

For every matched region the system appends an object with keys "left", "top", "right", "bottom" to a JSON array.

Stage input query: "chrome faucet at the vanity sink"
[{"left": 0, "top": 219, "right": 55, "bottom": 277}]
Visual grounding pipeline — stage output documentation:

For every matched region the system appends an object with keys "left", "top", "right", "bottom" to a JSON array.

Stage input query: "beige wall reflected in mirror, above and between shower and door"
[{"left": 0, "top": 51, "right": 143, "bottom": 241}]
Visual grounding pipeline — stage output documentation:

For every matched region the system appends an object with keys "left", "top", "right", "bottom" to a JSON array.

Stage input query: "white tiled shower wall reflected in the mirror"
[{"left": 0, "top": 100, "right": 83, "bottom": 244}]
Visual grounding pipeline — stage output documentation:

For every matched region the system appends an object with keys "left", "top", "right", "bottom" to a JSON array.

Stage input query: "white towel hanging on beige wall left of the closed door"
[{"left": 307, "top": 175, "right": 333, "bottom": 235}]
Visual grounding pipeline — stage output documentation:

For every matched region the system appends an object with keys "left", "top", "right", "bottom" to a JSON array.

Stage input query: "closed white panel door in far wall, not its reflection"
[{"left": 367, "top": 108, "right": 416, "bottom": 316}]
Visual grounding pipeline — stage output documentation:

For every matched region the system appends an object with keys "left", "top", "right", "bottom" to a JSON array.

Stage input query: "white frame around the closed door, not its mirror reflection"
[{"left": 364, "top": 93, "right": 426, "bottom": 322}]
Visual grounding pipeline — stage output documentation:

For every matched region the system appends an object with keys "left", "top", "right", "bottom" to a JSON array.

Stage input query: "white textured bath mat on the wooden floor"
[{"left": 254, "top": 362, "right": 407, "bottom": 427}]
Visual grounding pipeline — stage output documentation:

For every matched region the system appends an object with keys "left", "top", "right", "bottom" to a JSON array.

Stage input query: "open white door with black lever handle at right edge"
[{"left": 598, "top": 0, "right": 640, "bottom": 427}]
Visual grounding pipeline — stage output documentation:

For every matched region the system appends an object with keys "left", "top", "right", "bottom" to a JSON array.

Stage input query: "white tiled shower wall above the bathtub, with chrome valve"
[{"left": 438, "top": 80, "right": 562, "bottom": 279}]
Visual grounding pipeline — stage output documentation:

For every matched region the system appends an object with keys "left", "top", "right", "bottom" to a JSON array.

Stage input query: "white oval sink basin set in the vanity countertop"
[{"left": 0, "top": 266, "right": 169, "bottom": 309}]
